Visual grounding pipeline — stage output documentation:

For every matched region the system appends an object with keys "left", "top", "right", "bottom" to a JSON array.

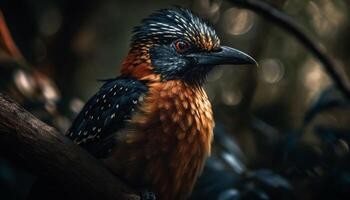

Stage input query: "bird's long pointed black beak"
[{"left": 188, "top": 46, "right": 258, "bottom": 66}]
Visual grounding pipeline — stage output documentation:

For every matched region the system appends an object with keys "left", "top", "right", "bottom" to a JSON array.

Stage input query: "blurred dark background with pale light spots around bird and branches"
[{"left": 0, "top": 0, "right": 350, "bottom": 200}]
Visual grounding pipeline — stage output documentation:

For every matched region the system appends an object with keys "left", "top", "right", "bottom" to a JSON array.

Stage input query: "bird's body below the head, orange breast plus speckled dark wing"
[{"left": 69, "top": 59, "right": 214, "bottom": 200}]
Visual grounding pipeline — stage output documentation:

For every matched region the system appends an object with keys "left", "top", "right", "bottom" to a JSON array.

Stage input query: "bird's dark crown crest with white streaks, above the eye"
[{"left": 132, "top": 7, "right": 220, "bottom": 51}]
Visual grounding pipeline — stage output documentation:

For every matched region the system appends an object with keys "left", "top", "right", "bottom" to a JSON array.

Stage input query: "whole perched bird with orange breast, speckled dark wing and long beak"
[{"left": 68, "top": 8, "right": 256, "bottom": 200}]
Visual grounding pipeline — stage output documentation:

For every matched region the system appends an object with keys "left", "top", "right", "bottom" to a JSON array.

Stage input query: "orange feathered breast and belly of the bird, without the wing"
[{"left": 107, "top": 80, "right": 214, "bottom": 200}]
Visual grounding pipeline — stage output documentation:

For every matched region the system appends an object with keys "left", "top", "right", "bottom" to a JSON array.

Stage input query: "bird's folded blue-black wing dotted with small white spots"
[{"left": 68, "top": 78, "right": 148, "bottom": 158}]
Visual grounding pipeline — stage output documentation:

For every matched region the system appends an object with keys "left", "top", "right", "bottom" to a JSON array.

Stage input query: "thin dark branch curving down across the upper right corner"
[{"left": 230, "top": 0, "right": 350, "bottom": 99}]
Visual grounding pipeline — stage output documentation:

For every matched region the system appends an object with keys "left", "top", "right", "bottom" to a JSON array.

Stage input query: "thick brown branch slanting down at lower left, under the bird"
[{"left": 0, "top": 93, "right": 140, "bottom": 200}]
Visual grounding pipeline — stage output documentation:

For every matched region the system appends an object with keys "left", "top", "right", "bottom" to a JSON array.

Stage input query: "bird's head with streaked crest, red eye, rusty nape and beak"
[{"left": 122, "top": 8, "right": 256, "bottom": 84}]
